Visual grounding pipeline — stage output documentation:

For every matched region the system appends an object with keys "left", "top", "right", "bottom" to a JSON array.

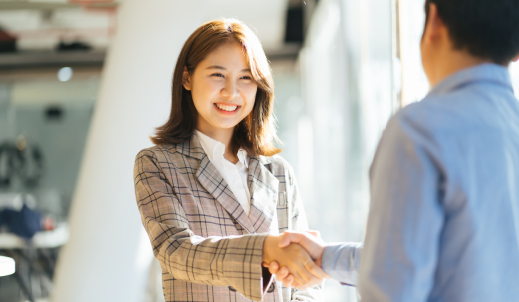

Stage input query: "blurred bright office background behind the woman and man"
[{"left": 0, "top": 0, "right": 519, "bottom": 302}]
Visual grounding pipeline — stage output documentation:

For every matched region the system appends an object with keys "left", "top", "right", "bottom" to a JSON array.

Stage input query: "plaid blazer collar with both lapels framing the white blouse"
[{"left": 176, "top": 135, "right": 279, "bottom": 234}]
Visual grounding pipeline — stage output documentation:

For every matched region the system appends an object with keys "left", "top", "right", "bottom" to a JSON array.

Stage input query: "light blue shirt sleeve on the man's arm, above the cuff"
[{"left": 358, "top": 114, "right": 444, "bottom": 302}]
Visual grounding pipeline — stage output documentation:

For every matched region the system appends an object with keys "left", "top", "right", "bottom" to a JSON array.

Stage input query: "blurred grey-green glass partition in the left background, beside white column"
[{"left": 0, "top": 67, "right": 101, "bottom": 220}]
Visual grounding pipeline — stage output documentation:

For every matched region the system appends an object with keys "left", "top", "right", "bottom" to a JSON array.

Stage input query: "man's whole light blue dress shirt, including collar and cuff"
[{"left": 323, "top": 64, "right": 519, "bottom": 302}]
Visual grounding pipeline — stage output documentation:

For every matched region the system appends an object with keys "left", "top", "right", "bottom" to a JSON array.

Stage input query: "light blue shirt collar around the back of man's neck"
[{"left": 429, "top": 63, "right": 513, "bottom": 96}]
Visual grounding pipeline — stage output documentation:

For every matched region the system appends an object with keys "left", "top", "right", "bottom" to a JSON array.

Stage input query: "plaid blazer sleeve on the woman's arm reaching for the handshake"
[{"left": 134, "top": 150, "right": 267, "bottom": 301}]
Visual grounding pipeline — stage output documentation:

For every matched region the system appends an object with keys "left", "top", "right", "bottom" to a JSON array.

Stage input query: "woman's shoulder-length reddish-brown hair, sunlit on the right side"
[{"left": 151, "top": 19, "right": 281, "bottom": 156}]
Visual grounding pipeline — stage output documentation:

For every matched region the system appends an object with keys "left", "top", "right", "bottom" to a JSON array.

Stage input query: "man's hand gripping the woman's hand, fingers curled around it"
[{"left": 265, "top": 231, "right": 330, "bottom": 288}]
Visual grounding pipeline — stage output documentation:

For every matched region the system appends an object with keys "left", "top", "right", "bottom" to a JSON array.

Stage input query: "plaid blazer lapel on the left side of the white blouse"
[{"left": 181, "top": 134, "right": 254, "bottom": 234}]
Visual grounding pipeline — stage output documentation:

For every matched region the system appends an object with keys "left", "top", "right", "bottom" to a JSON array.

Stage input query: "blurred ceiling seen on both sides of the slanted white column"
[{"left": 0, "top": 0, "right": 294, "bottom": 52}]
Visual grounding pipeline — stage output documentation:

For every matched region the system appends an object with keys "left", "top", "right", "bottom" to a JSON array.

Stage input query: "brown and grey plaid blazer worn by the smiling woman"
[{"left": 134, "top": 135, "right": 322, "bottom": 302}]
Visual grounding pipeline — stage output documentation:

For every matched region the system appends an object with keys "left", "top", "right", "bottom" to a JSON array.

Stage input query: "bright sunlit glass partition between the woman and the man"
[{"left": 297, "top": 0, "right": 398, "bottom": 302}]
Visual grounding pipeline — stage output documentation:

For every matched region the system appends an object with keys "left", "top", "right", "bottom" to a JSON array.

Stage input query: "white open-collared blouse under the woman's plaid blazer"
[{"left": 195, "top": 130, "right": 250, "bottom": 216}]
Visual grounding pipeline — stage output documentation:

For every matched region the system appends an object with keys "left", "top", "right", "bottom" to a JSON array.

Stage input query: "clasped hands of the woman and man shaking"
[{"left": 263, "top": 231, "right": 330, "bottom": 289}]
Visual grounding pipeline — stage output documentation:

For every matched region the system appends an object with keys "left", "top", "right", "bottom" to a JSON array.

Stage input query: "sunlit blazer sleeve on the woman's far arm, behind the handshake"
[{"left": 285, "top": 166, "right": 324, "bottom": 302}]
